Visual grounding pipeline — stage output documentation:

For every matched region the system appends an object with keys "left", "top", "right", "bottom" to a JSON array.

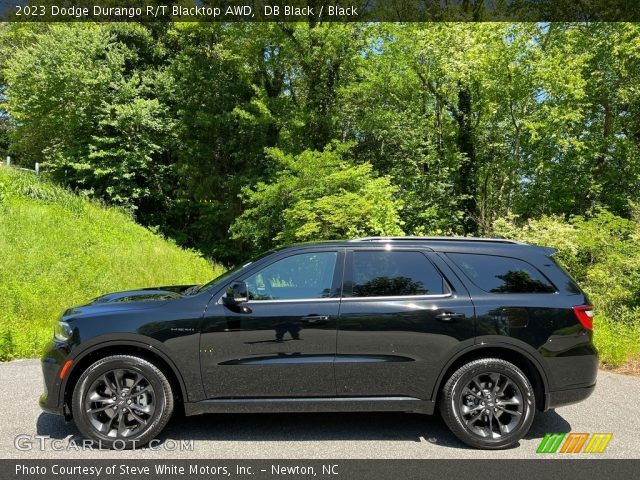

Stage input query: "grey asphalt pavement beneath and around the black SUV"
[{"left": 0, "top": 360, "right": 640, "bottom": 459}]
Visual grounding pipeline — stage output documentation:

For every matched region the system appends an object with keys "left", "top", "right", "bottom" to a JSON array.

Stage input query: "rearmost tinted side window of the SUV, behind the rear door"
[{"left": 447, "top": 253, "right": 556, "bottom": 293}]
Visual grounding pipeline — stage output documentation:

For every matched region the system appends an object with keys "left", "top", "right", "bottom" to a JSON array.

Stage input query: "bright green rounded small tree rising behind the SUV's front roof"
[{"left": 232, "top": 147, "right": 403, "bottom": 251}]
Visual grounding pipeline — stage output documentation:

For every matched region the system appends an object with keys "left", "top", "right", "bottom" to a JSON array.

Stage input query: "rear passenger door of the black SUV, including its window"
[{"left": 335, "top": 245, "right": 474, "bottom": 399}]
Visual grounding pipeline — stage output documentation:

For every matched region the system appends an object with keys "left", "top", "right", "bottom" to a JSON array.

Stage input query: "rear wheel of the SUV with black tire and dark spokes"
[{"left": 440, "top": 358, "right": 536, "bottom": 450}]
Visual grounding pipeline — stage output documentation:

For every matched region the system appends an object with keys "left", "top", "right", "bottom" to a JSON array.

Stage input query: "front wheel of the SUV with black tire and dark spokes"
[{"left": 71, "top": 355, "right": 174, "bottom": 450}]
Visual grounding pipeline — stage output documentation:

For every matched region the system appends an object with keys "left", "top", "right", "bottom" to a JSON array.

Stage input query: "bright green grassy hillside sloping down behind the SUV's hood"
[{"left": 0, "top": 166, "right": 222, "bottom": 360}]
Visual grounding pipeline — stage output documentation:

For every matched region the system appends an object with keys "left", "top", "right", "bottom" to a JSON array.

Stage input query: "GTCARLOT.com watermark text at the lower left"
[{"left": 13, "top": 434, "right": 194, "bottom": 452}]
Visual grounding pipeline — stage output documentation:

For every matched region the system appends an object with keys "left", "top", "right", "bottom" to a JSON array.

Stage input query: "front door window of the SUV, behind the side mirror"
[{"left": 246, "top": 252, "right": 338, "bottom": 300}]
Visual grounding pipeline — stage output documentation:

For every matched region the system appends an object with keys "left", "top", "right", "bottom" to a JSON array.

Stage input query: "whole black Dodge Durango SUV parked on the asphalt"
[{"left": 40, "top": 237, "right": 597, "bottom": 449}]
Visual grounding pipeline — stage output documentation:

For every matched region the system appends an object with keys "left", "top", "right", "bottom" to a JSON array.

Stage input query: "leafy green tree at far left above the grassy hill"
[{"left": 5, "top": 24, "right": 178, "bottom": 224}]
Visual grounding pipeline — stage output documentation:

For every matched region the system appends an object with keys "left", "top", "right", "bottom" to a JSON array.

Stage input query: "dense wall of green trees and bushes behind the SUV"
[{"left": 0, "top": 22, "right": 640, "bottom": 368}]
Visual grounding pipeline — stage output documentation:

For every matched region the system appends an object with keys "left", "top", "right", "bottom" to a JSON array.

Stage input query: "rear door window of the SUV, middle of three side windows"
[{"left": 352, "top": 252, "right": 444, "bottom": 297}]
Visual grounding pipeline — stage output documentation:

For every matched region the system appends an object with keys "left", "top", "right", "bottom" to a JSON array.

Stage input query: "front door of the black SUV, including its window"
[{"left": 200, "top": 249, "right": 344, "bottom": 398}]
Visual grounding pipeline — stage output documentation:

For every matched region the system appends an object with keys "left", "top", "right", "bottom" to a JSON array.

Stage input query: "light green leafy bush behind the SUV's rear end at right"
[{"left": 494, "top": 209, "right": 640, "bottom": 367}]
